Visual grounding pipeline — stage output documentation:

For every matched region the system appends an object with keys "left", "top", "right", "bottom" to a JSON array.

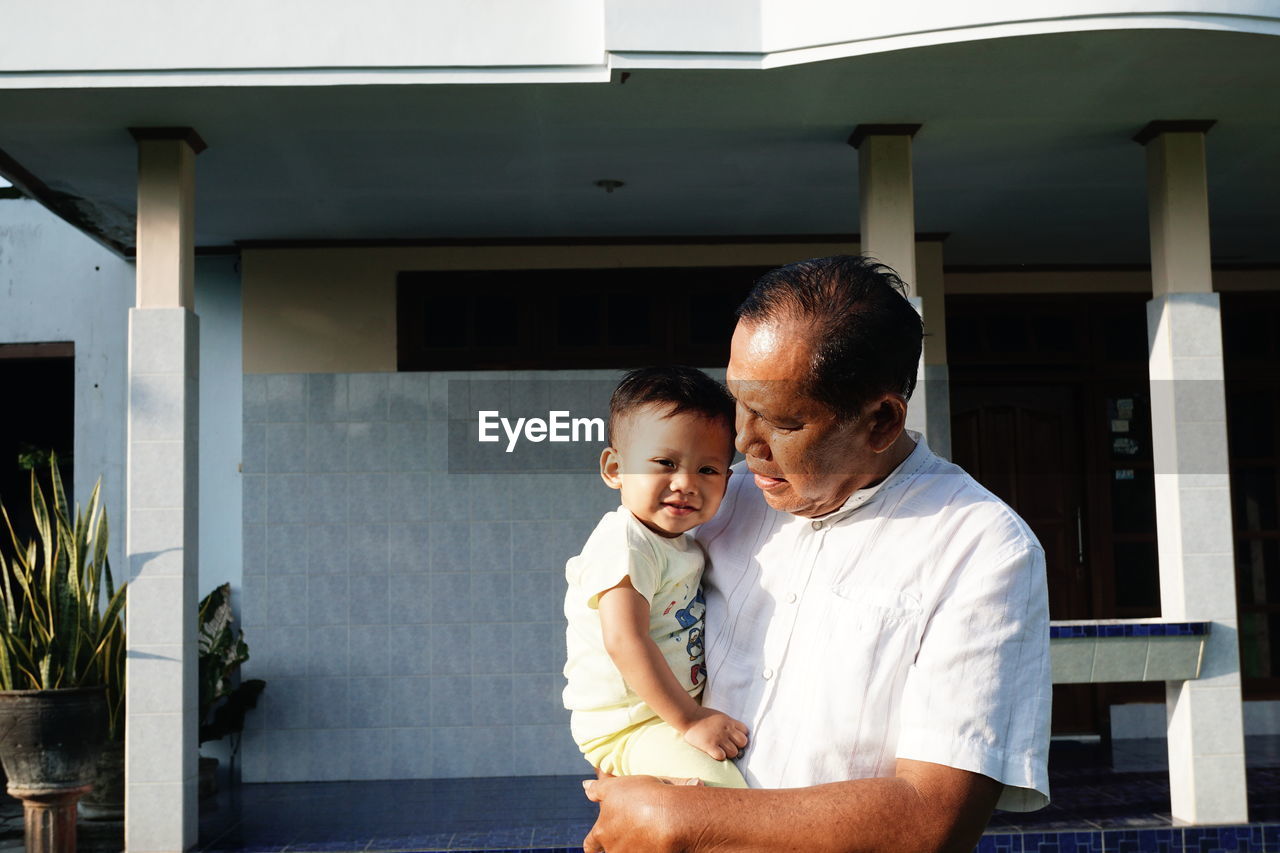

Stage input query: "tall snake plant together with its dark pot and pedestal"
[{"left": 0, "top": 456, "right": 124, "bottom": 852}]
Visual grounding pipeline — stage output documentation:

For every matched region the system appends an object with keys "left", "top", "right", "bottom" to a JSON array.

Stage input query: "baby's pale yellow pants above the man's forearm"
[{"left": 580, "top": 717, "right": 746, "bottom": 788}]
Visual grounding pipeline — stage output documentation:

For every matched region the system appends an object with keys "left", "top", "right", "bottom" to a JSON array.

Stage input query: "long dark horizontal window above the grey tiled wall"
[{"left": 397, "top": 266, "right": 768, "bottom": 370}]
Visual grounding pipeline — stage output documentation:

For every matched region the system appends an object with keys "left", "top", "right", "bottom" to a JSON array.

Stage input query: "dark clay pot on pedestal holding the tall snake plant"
[{"left": 0, "top": 686, "right": 106, "bottom": 853}]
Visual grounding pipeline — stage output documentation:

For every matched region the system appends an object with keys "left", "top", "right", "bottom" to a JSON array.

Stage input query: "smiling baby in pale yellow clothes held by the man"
[{"left": 564, "top": 368, "right": 748, "bottom": 788}]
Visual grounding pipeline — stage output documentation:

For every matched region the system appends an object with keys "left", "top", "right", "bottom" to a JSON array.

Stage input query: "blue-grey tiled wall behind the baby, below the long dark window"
[{"left": 242, "top": 371, "right": 617, "bottom": 781}]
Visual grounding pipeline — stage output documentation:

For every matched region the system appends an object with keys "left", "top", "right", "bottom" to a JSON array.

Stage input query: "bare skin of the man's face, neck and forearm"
[{"left": 582, "top": 320, "right": 1002, "bottom": 853}]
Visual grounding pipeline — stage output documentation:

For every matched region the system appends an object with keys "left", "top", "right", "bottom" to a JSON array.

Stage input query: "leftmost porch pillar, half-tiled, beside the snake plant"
[{"left": 124, "top": 128, "right": 205, "bottom": 853}]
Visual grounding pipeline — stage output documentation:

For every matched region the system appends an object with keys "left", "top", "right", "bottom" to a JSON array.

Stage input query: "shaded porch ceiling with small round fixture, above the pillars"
[{"left": 0, "top": 29, "right": 1280, "bottom": 265}]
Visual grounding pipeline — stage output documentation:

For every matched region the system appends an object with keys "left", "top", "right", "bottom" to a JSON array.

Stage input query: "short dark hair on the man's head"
[{"left": 737, "top": 255, "right": 924, "bottom": 418}]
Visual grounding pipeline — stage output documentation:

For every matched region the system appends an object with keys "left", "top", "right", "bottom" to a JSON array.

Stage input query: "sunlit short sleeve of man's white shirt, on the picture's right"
[{"left": 897, "top": 544, "right": 1052, "bottom": 812}]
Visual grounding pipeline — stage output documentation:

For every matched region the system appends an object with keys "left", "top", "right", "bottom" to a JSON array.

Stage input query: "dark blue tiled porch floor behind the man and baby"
[{"left": 0, "top": 736, "right": 1280, "bottom": 853}]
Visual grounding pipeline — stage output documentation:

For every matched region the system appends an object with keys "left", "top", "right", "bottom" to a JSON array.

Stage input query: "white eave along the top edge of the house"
[{"left": 0, "top": 0, "right": 1280, "bottom": 88}]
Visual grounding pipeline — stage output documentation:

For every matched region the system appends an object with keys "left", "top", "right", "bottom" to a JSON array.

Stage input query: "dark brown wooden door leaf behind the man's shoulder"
[{"left": 951, "top": 383, "right": 1097, "bottom": 734}]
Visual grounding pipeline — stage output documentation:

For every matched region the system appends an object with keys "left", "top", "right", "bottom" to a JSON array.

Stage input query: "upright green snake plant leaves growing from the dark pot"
[{"left": 0, "top": 457, "right": 124, "bottom": 731}]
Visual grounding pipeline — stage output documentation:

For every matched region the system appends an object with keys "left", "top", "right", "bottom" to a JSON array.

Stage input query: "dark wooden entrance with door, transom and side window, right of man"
[{"left": 947, "top": 293, "right": 1164, "bottom": 735}]
